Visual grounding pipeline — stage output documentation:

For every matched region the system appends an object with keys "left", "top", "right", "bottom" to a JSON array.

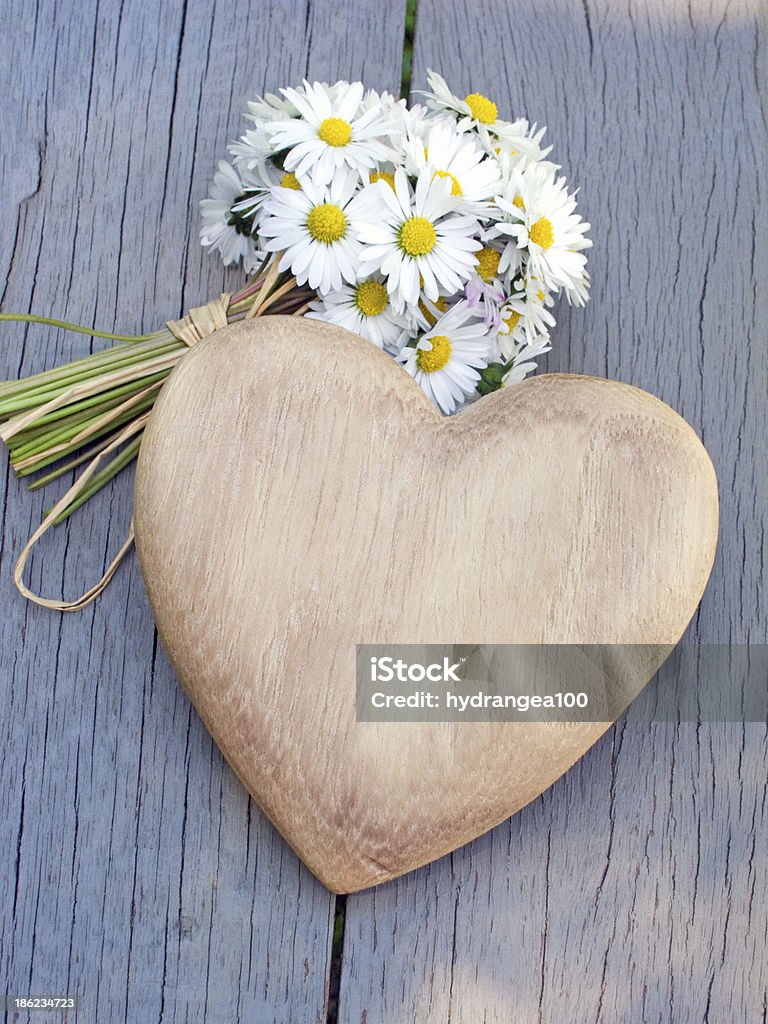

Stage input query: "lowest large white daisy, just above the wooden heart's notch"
[{"left": 397, "top": 302, "right": 489, "bottom": 415}]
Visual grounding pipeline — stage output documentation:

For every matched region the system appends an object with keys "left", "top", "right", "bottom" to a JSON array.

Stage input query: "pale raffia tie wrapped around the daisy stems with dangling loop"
[{"left": 13, "top": 292, "right": 229, "bottom": 611}]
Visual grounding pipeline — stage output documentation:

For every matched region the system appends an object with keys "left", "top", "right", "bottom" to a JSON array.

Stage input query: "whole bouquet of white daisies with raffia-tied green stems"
[{"left": 0, "top": 73, "right": 592, "bottom": 607}]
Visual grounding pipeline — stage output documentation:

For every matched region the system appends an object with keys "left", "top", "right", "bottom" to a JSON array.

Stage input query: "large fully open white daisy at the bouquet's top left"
[{"left": 264, "top": 82, "right": 396, "bottom": 185}]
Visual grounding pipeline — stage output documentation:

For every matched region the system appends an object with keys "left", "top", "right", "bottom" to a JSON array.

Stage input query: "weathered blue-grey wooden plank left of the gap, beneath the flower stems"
[{"left": 0, "top": 0, "right": 404, "bottom": 1024}]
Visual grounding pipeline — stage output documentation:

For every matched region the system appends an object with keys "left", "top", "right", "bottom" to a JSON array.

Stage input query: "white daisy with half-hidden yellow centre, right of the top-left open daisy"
[{"left": 403, "top": 118, "right": 502, "bottom": 217}]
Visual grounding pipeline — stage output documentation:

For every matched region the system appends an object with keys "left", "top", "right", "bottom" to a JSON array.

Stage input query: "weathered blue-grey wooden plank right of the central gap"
[{"left": 340, "top": 0, "right": 768, "bottom": 1024}]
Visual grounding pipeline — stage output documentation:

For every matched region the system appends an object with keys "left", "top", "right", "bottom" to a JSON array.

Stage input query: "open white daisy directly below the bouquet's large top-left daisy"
[{"left": 259, "top": 171, "right": 370, "bottom": 294}]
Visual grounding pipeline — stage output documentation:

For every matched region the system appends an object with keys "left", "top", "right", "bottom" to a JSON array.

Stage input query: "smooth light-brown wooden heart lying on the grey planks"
[{"left": 135, "top": 316, "right": 718, "bottom": 892}]
